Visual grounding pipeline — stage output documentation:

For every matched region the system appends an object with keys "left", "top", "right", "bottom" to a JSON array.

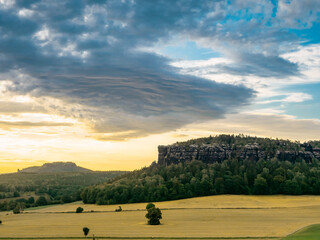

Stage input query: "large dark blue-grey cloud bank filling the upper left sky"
[{"left": 0, "top": 0, "right": 310, "bottom": 139}]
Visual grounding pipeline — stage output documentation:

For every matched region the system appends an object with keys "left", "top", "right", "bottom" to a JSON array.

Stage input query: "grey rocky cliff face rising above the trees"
[{"left": 158, "top": 143, "right": 320, "bottom": 165}]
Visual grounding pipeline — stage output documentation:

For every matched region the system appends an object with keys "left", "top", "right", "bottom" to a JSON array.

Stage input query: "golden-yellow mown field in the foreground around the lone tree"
[{"left": 0, "top": 195, "right": 320, "bottom": 239}]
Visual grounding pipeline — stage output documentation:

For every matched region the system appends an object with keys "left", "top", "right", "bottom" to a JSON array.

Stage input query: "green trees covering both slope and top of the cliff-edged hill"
[{"left": 81, "top": 135, "right": 320, "bottom": 204}]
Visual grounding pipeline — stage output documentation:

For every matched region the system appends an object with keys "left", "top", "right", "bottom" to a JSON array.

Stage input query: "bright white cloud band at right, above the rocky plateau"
[{"left": 172, "top": 44, "right": 320, "bottom": 111}]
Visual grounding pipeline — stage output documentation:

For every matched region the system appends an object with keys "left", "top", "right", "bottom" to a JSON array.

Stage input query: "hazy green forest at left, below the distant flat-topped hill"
[{"left": 0, "top": 171, "right": 126, "bottom": 211}]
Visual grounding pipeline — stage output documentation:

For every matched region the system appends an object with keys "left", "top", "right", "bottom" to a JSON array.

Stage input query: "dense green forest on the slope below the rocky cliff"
[{"left": 81, "top": 159, "right": 320, "bottom": 204}]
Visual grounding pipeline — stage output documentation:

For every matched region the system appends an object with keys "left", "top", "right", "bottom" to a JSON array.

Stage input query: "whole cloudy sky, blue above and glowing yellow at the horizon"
[{"left": 0, "top": 0, "right": 320, "bottom": 173}]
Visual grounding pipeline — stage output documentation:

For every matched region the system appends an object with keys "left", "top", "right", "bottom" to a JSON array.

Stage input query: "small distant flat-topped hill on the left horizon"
[{"left": 19, "top": 162, "right": 92, "bottom": 173}]
